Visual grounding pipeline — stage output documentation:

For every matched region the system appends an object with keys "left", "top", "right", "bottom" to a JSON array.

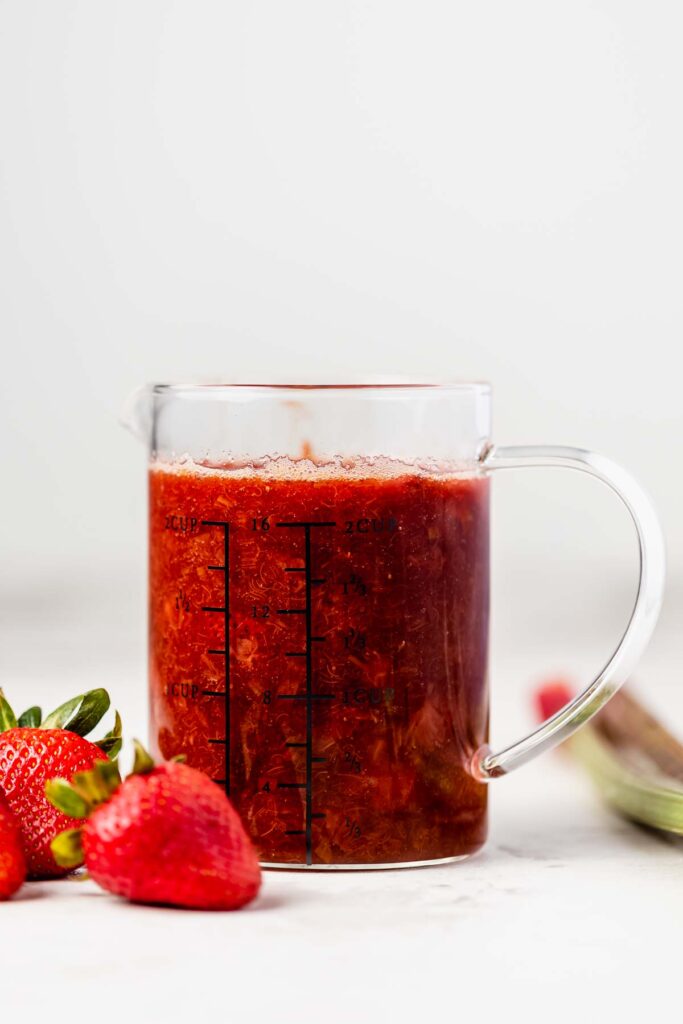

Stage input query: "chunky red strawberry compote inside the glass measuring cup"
[{"left": 150, "top": 459, "right": 488, "bottom": 866}]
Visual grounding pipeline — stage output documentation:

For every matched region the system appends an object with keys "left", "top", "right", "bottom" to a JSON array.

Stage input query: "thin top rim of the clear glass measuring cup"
[{"left": 147, "top": 380, "right": 492, "bottom": 396}]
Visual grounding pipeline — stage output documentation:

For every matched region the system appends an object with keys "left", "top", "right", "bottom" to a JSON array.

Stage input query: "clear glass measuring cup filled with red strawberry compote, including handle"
[{"left": 122, "top": 383, "right": 665, "bottom": 868}]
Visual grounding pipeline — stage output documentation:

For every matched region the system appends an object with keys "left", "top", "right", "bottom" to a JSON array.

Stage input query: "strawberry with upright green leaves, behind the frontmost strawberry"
[{"left": 0, "top": 689, "right": 121, "bottom": 879}]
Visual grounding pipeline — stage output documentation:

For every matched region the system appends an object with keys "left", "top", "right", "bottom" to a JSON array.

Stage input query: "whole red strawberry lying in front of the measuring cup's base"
[{"left": 47, "top": 744, "right": 261, "bottom": 910}]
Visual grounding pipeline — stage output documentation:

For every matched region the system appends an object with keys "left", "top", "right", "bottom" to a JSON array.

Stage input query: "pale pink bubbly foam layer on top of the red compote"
[{"left": 151, "top": 455, "right": 482, "bottom": 480}]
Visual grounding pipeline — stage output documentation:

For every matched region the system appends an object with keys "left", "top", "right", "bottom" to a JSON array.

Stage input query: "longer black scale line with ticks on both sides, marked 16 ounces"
[{"left": 276, "top": 520, "right": 337, "bottom": 864}]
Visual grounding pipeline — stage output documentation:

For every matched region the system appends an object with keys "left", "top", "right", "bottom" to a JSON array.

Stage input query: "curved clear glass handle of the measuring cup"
[{"left": 472, "top": 445, "right": 665, "bottom": 781}]
